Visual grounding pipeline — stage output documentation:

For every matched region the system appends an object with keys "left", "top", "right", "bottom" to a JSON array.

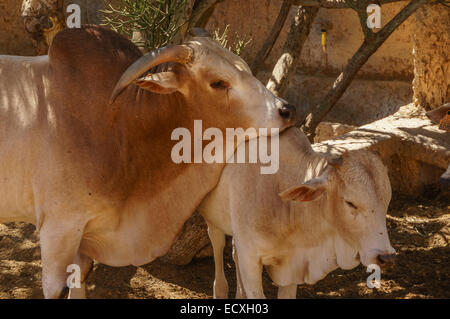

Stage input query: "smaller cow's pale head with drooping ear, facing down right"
[{"left": 280, "top": 151, "right": 395, "bottom": 269}]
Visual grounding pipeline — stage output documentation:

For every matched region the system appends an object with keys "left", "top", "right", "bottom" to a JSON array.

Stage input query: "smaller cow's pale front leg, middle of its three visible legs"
[{"left": 235, "top": 238, "right": 266, "bottom": 299}]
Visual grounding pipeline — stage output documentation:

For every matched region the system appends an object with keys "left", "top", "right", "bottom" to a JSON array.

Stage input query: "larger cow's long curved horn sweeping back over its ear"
[{"left": 109, "top": 45, "right": 194, "bottom": 104}]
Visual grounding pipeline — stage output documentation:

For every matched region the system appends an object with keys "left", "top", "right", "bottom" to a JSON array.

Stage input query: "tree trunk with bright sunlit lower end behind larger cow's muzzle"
[{"left": 267, "top": 7, "right": 319, "bottom": 96}]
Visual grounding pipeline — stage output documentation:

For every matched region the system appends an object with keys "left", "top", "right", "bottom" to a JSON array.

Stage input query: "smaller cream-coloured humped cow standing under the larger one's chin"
[{"left": 199, "top": 128, "right": 395, "bottom": 298}]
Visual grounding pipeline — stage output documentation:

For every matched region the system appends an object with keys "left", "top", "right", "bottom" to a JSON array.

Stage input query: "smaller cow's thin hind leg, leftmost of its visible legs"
[{"left": 208, "top": 224, "right": 228, "bottom": 298}]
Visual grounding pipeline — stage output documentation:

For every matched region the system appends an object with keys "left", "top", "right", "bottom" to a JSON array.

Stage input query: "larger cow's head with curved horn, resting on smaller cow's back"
[{"left": 111, "top": 30, "right": 295, "bottom": 139}]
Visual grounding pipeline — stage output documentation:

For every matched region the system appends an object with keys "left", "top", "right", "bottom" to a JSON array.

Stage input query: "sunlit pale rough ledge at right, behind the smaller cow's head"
[{"left": 313, "top": 104, "right": 450, "bottom": 197}]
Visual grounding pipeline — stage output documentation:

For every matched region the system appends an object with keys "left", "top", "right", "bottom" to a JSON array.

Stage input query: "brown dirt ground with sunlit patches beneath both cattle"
[{"left": 0, "top": 196, "right": 450, "bottom": 298}]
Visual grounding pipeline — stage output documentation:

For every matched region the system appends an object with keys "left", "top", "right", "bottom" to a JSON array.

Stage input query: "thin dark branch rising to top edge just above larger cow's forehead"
[{"left": 250, "top": 0, "right": 295, "bottom": 75}]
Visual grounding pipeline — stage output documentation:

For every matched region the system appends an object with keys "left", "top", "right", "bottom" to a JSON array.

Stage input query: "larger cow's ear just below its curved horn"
[{"left": 135, "top": 72, "right": 178, "bottom": 94}]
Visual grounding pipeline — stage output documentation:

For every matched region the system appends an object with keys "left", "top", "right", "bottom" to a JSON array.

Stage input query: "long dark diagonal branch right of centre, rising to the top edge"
[{"left": 303, "top": 0, "right": 430, "bottom": 140}]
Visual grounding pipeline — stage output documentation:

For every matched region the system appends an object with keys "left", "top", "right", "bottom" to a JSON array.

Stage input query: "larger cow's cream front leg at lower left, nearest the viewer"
[{"left": 40, "top": 216, "right": 84, "bottom": 298}]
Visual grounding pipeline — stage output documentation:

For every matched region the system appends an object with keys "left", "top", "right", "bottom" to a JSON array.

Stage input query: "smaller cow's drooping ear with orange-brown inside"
[{"left": 279, "top": 177, "right": 327, "bottom": 202}]
